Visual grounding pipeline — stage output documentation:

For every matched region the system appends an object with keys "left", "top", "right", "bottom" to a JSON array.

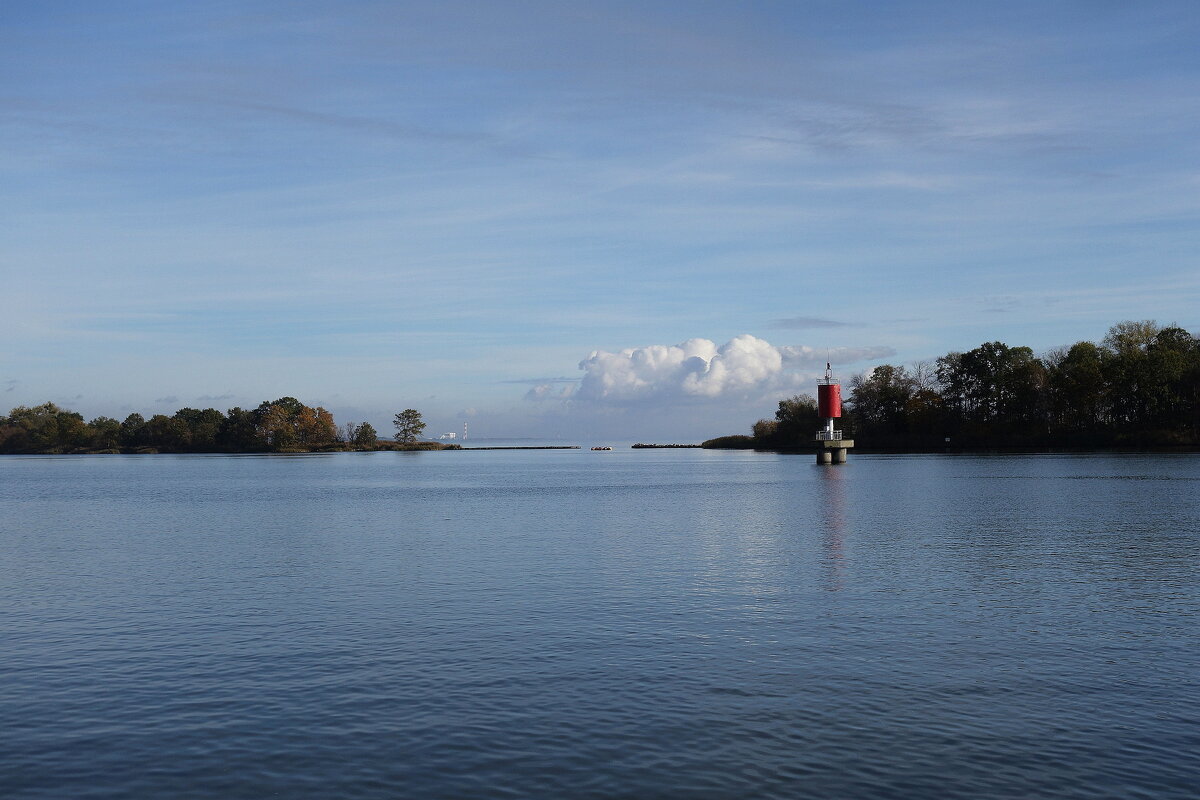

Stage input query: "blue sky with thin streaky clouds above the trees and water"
[{"left": 0, "top": 0, "right": 1200, "bottom": 441}]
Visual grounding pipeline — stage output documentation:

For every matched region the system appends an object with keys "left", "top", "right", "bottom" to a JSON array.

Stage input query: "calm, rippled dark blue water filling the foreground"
[{"left": 0, "top": 450, "right": 1200, "bottom": 799}]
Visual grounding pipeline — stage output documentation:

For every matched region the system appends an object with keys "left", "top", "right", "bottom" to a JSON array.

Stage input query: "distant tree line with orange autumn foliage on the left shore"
[{"left": 0, "top": 397, "right": 433, "bottom": 453}]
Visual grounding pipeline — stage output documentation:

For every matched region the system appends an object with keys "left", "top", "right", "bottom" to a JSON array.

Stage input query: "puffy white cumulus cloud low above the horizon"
[{"left": 552, "top": 333, "right": 895, "bottom": 407}]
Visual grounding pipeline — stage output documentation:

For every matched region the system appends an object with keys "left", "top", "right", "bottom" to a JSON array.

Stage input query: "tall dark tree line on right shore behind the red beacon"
[{"left": 706, "top": 320, "right": 1200, "bottom": 451}]
